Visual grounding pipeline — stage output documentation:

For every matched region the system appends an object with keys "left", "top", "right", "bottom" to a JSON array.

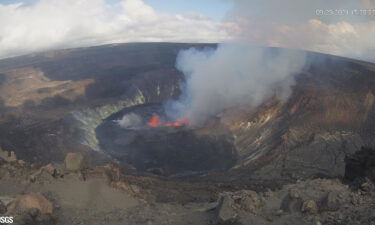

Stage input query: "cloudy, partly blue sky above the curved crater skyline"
[{"left": 0, "top": 0, "right": 375, "bottom": 61}]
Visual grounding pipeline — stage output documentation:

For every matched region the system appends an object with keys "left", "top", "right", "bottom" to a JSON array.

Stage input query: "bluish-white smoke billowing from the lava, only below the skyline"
[{"left": 166, "top": 44, "right": 306, "bottom": 126}]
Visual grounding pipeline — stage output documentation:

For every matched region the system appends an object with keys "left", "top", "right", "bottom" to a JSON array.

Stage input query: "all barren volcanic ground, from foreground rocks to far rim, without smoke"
[{"left": 0, "top": 43, "right": 375, "bottom": 225}]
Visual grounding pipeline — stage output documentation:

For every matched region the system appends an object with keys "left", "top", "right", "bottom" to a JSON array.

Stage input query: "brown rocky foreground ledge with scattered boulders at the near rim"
[{"left": 0, "top": 153, "right": 375, "bottom": 225}]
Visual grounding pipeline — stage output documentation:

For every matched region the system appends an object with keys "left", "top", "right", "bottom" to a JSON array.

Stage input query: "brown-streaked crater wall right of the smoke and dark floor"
[{"left": 223, "top": 55, "right": 375, "bottom": 179}]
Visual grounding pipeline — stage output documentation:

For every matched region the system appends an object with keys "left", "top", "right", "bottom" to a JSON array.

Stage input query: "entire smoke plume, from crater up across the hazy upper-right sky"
[{"left": 166, "top": 0, "right": 375, "bottom": 125}]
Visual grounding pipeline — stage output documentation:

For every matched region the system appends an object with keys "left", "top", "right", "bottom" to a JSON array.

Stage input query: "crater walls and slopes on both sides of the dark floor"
[{"left": 0, "top": 43, "right": 375, "bottom": 182}]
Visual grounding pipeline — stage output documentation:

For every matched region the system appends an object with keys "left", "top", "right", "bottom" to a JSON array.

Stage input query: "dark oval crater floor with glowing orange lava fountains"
[{"left": 96, "top": 104, "right": 236, "bottom": 176}]
